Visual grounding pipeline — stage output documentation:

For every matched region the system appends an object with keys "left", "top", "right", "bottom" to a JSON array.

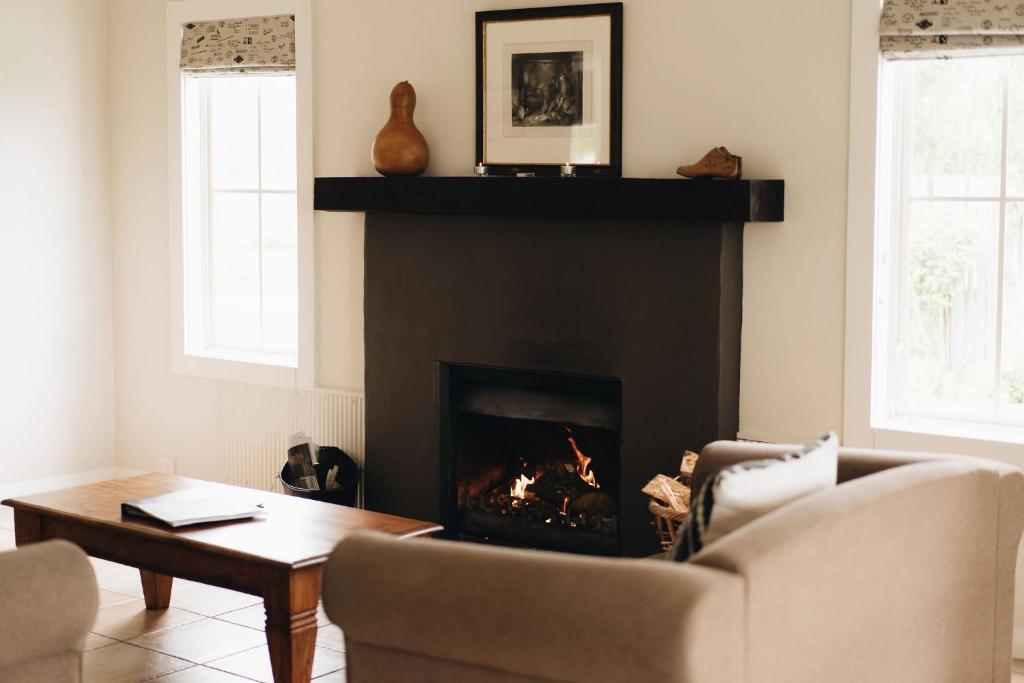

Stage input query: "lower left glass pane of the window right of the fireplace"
[{"left": 897, "top": 202, "right": 999, "bottom": 419}]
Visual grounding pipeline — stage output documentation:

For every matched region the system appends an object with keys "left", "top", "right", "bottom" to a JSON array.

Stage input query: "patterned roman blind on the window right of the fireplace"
[{"left": 879, "top": 0, "right": 1024, "bottom": 59}]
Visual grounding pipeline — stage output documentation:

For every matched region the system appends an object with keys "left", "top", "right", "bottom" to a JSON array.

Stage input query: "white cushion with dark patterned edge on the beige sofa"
[{"left": 668, "top": 432, "right": 839, "bottom": 562}]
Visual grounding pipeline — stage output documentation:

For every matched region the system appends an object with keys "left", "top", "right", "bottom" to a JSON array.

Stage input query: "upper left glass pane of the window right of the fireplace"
[{"left": 907, "top": 57, "right": 1004, "bottom": 197}]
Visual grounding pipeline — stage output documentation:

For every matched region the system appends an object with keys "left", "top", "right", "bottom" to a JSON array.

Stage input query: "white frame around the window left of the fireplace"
[{"left": 167, "top": 0, "right": 315, "bottom": 389}]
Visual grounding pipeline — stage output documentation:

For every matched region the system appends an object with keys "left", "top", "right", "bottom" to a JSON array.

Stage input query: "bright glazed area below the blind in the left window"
[{"left": 181, "top": 74, "right": 298, "bottom": 367}]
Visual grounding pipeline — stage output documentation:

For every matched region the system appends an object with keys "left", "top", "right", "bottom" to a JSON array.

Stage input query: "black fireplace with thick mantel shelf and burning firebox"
[{"left": 315, "top": 178, "right": 782, "bottom": 556}]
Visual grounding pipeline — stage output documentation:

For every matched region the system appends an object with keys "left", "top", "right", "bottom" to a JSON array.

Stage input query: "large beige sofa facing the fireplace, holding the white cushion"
[{"left": 324, "top": 441, "right": 1024, "bottom": 683}]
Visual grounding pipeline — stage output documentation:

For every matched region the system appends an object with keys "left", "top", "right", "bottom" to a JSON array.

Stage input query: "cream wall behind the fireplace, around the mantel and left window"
[{"left": 109, "top": 0, "right": 850, "bottom": 475}]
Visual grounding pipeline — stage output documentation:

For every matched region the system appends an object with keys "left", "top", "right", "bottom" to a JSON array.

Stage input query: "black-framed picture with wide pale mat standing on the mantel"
[{"left": 476, "top": 2, "right": 623, "bottom": 176}]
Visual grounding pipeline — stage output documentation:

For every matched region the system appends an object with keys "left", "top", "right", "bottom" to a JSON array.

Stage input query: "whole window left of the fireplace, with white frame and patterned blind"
[{"left": 165, "top": 0, "right": 315, "bottom": 388}]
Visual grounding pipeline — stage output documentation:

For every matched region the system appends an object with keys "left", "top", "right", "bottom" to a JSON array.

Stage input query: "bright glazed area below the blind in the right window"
[{"left": 871, "top": 55, "right": 1024, "bottom": 431}]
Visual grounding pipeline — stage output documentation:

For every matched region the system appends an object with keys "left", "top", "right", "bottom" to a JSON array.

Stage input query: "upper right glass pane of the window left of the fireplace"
[{"left": 260, "top": 76, "right": 296, "bottom": 190}]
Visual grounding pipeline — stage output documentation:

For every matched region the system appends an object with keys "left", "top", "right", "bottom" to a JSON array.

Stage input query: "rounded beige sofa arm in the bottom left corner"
[{"left": 0, "top": 541, "right": 99, "bottom": 683}]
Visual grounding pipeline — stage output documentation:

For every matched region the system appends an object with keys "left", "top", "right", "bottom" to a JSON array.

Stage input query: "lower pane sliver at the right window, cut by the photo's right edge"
[{"left": 1000, "top": 204, "right": 1024, "bottom": 424}]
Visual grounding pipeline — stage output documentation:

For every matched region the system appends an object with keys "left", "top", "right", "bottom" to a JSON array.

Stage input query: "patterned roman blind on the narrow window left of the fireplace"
[{"left": 180, "top": 14, "right": 295, "bottom": 74}]
